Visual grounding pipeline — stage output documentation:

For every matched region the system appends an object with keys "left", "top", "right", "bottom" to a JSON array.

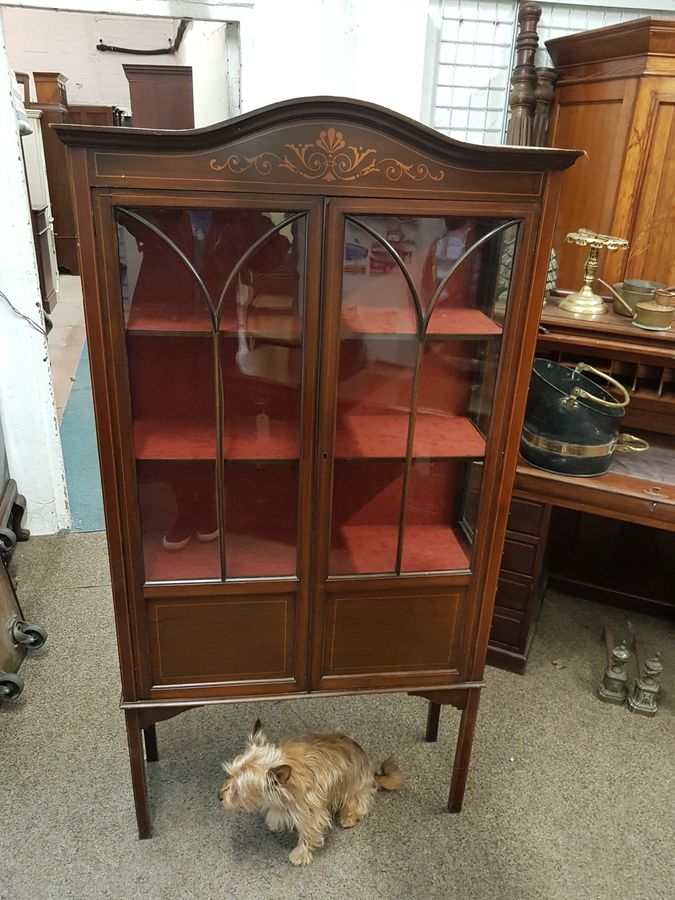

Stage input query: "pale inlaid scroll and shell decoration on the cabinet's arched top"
[{"left": 209, "top": 128, "right": 445, "bottom": 181}]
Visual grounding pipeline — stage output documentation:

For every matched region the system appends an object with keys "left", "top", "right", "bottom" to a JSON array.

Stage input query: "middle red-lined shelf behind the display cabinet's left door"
[{"left": 134, "top": 417, "right": 300, "bottom": 460}]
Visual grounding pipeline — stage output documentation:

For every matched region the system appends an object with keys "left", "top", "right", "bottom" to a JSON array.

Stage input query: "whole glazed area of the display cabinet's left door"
[{"left": 117, "top": 208, "right": 305, "bottom": 581}]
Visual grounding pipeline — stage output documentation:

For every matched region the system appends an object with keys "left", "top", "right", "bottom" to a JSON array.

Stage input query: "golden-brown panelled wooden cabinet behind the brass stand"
[{"left": 546, "top": 18, "right": 675, "bottom": 290}]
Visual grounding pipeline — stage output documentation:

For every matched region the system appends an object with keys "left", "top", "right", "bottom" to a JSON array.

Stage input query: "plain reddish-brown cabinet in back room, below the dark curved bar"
[{"left": 122, "top": 63, "right": 194, "bottom": 128}]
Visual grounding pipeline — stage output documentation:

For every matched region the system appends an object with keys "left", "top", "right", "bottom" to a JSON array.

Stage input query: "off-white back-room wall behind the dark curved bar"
[{"left": 3, "top": 9, "right": 178, "bottom": 109}]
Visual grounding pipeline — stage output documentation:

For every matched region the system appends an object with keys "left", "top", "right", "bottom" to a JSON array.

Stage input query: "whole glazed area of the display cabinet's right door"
[{"left": 329, "top": 216, "right": 518, "bottom": 575}]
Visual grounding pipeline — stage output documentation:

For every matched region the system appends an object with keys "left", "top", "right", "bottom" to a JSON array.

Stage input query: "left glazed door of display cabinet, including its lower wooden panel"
[{"left": 102, "top": 193, "right": 321, "bottom": 697}]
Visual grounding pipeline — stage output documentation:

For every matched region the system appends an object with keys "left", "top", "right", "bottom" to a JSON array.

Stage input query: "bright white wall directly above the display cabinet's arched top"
[{"left": 242, "top": 0, "right": 427, "bottom": 118}]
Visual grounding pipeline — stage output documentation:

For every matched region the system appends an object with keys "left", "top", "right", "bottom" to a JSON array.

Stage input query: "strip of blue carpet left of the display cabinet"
[{"left": 61, "top": 342, "right": 105, "bottom": 531}]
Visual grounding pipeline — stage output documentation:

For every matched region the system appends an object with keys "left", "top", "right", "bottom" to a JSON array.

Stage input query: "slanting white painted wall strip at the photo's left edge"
[{"left": 0, "top": 10, "right": 70, "bottom": 534}]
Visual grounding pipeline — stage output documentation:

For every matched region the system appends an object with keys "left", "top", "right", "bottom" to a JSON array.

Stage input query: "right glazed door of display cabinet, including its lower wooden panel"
[{"left": 314, "top": 201, "right": 521, "bottom": 689}]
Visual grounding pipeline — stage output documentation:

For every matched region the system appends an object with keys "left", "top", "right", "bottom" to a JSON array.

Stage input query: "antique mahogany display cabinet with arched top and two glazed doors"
[{"left": 57, "top": 98, "right": 579, "bottom": 837}]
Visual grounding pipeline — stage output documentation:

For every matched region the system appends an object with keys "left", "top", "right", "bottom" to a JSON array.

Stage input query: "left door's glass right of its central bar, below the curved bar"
[{"left": 220, "top": 214, "right": 306, "bottom": 578}]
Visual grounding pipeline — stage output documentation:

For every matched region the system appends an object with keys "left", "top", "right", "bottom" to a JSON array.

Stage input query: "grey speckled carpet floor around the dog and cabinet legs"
[{"left": 0, "top": 534, "right": 675, "bottom": 900}]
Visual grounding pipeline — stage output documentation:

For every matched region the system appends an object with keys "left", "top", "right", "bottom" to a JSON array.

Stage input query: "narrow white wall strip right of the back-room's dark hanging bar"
[{"left": 174, "top": 22, "right": 232, "bottom": 128}]
